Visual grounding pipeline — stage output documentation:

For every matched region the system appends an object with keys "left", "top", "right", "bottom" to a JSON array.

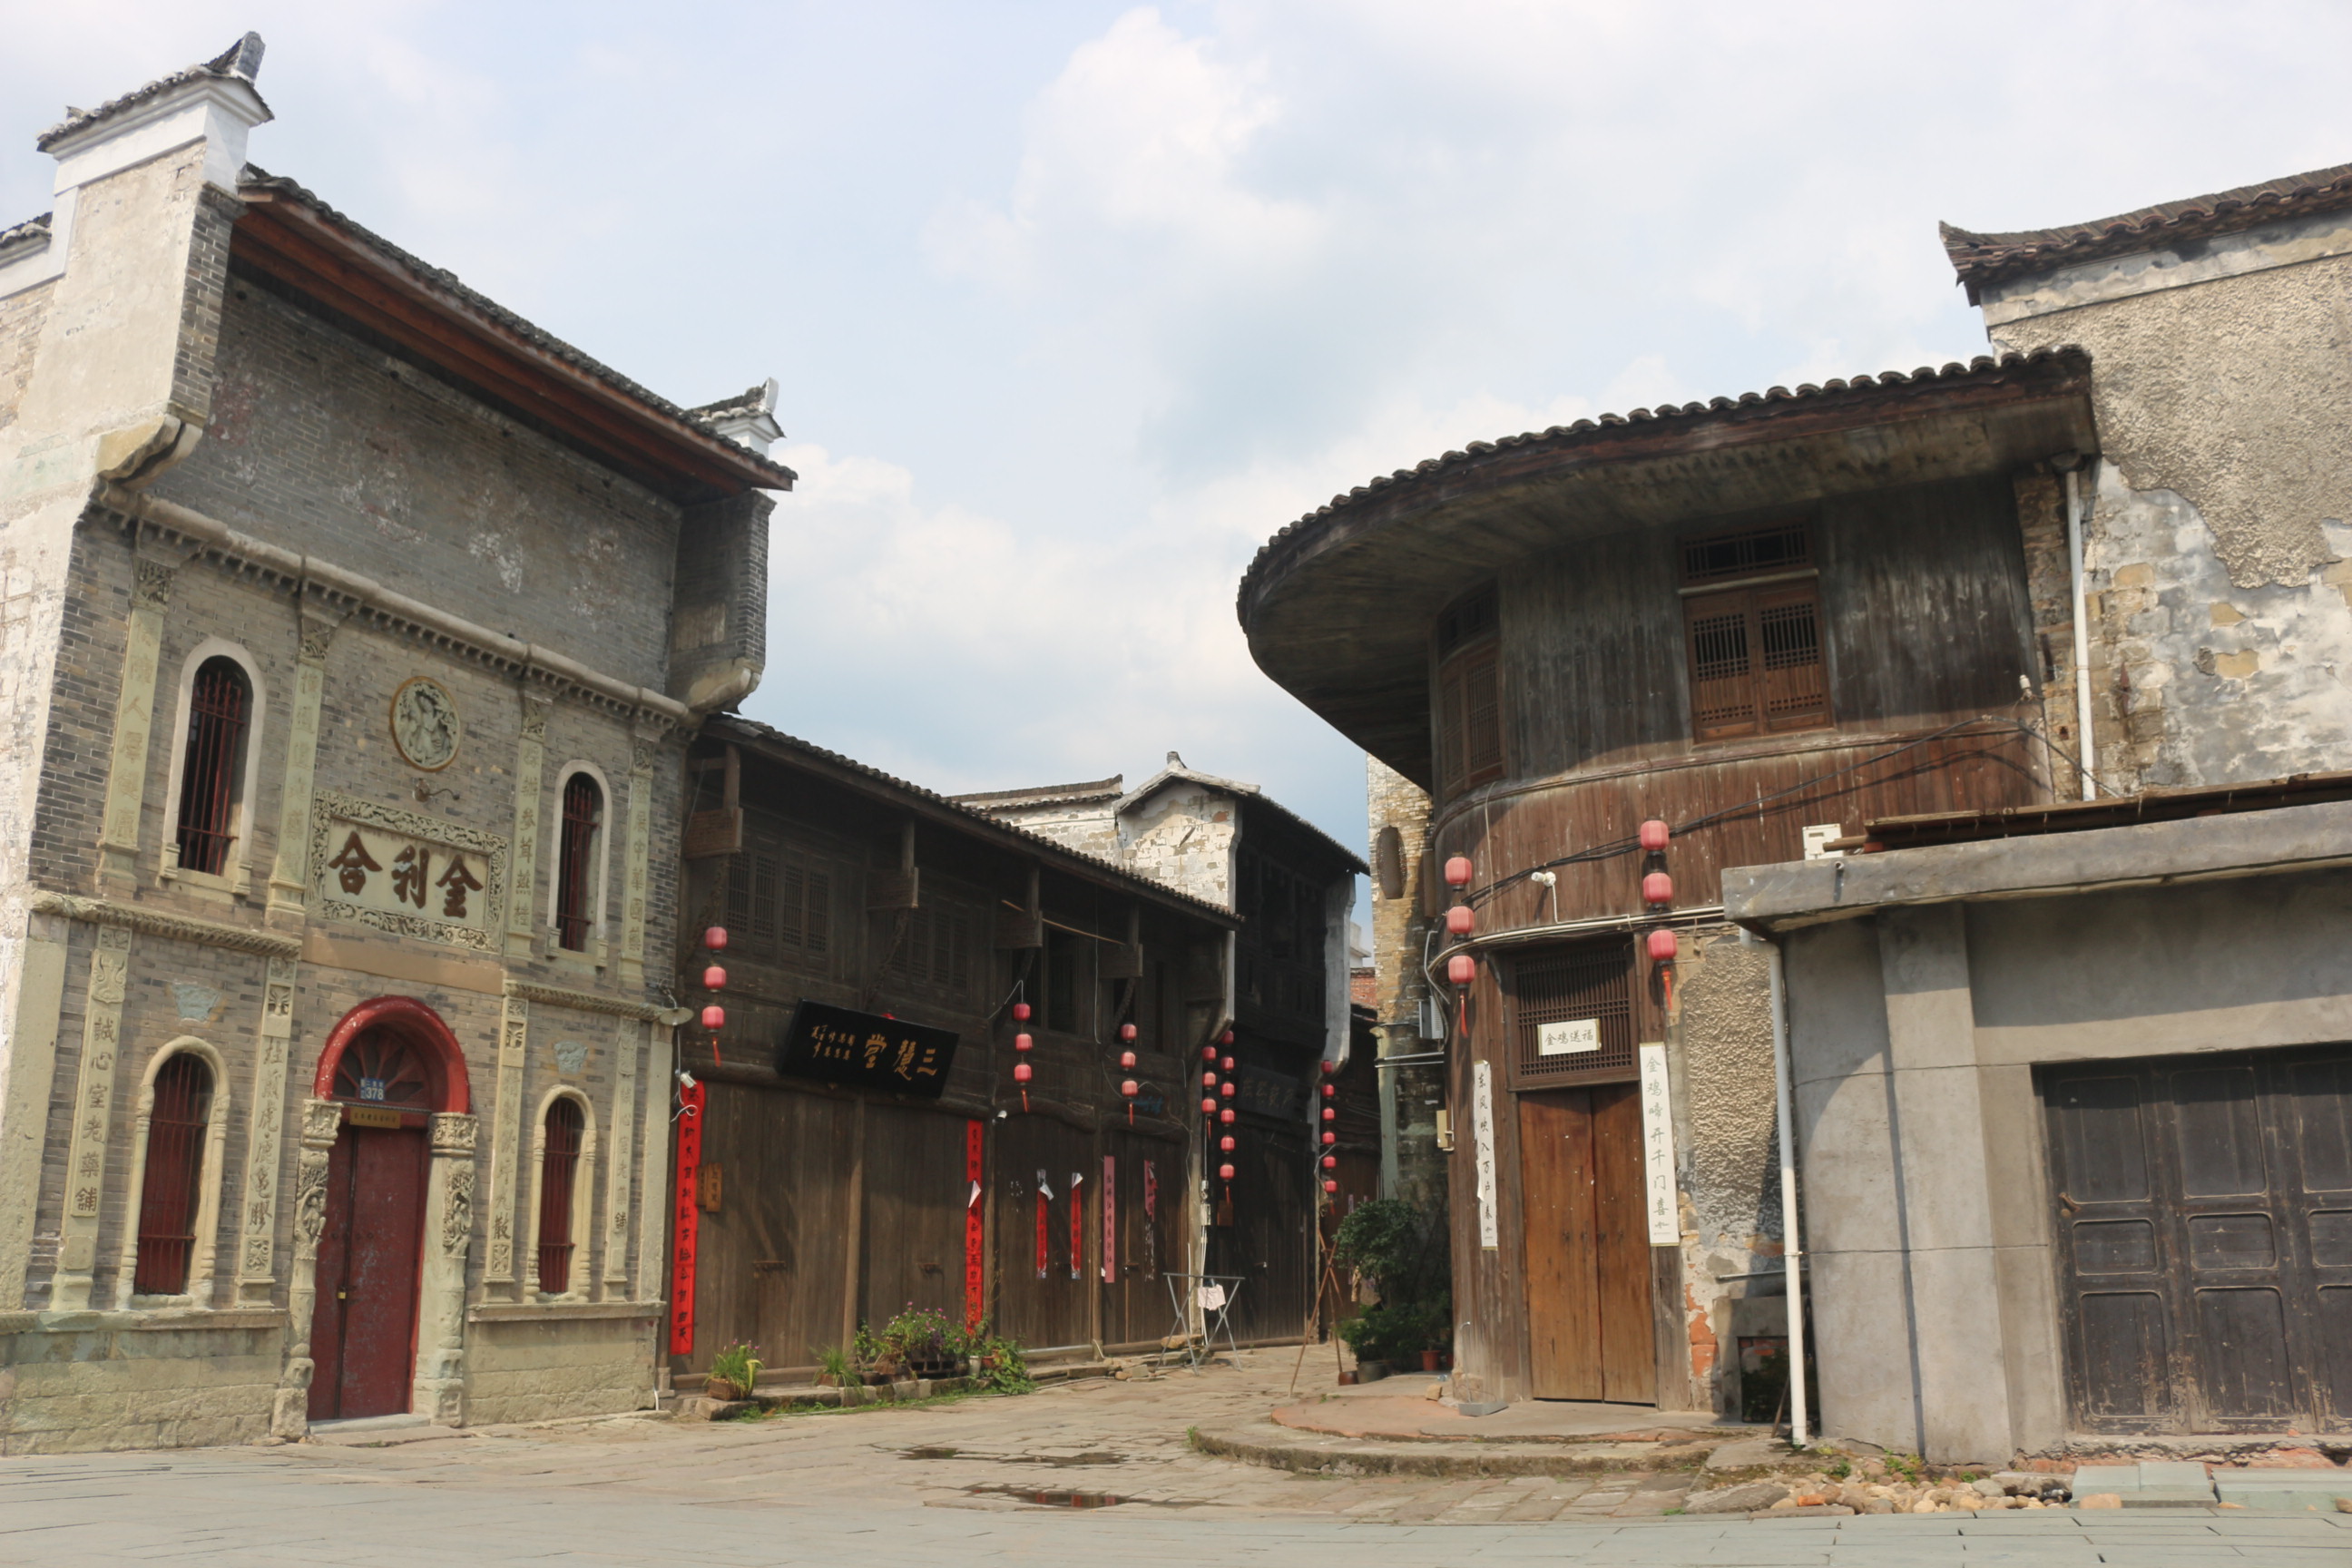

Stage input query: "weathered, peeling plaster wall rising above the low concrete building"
[{"left": 1987, "top": 230, "right": 2352, "bottom": 792}]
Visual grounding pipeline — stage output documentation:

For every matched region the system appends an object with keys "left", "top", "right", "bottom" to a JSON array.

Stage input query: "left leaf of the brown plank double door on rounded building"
[{"left": 1519, "top": 1088, "right": 1606, "bottom": 1398}]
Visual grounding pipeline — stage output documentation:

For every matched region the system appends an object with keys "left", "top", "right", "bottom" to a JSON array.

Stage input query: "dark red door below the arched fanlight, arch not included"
[{"left": 310, "top": 1126, "right": 428, "bottom": 1420}]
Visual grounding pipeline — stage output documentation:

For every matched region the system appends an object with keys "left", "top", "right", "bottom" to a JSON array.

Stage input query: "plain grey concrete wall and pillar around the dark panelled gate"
[{"left": 1785, "top": 872, "right": 2352, "bottom": 1462}]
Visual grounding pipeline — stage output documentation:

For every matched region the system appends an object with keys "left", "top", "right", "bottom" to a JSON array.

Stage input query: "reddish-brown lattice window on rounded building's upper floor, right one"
[{"left": 1681, "top": 524, "right": 1830, "bottom": 740}]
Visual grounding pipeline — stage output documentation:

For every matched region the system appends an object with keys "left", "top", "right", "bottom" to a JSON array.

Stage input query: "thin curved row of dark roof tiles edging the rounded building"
[{"left": 1237, "top": 348, "right": 2082, "bottom": 623}]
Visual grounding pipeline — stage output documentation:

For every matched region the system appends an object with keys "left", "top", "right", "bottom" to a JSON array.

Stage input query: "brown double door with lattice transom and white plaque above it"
[{"left": 1507, "top": 936, "right": 1658, "bottom": 1404}]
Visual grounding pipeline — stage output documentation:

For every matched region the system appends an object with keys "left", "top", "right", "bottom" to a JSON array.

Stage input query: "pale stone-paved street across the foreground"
[{"left": 0, "top": 1352, "right": 2352, "bottom": 1568}]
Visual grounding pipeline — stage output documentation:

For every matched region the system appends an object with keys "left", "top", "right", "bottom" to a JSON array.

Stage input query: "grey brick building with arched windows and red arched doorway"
[{"left": 0, "top": 35, "right": 793, "bottom": 1453}]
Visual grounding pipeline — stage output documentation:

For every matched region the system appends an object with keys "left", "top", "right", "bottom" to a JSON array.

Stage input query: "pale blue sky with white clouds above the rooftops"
[{"left": 0, "top": 0, "right": 2352, "bottom": 893}]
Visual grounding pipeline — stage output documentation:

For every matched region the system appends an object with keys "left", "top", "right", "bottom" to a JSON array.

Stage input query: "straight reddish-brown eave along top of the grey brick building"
[{"left": 230, "top": 181, "right": 795, "bottom": 505}]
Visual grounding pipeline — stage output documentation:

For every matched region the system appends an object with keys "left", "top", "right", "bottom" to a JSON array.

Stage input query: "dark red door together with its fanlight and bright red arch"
[{"left": 310, "top": 996, "right": 466, "bottom": 1420}]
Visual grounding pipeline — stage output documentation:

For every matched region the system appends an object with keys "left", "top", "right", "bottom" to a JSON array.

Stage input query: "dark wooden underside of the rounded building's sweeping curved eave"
[{"left": 1237, "top": 350, "right": 2098, "bottom": 788}]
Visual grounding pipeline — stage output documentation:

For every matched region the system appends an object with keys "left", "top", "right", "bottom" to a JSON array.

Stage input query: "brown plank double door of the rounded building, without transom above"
[{"left": 1519, "top": 1083, "right": 1658, "bottom": 1404}]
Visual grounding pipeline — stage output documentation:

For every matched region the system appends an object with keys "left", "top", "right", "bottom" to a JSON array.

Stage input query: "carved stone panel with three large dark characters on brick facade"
[{"left": 310, "top": 789, "right": 505, "bottom": 952}]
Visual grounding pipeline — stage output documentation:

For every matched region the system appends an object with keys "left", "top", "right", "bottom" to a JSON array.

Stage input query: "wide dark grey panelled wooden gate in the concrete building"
[{"left": 2039, "top": 1046, "right": 2352, "bottom": 1432}]
